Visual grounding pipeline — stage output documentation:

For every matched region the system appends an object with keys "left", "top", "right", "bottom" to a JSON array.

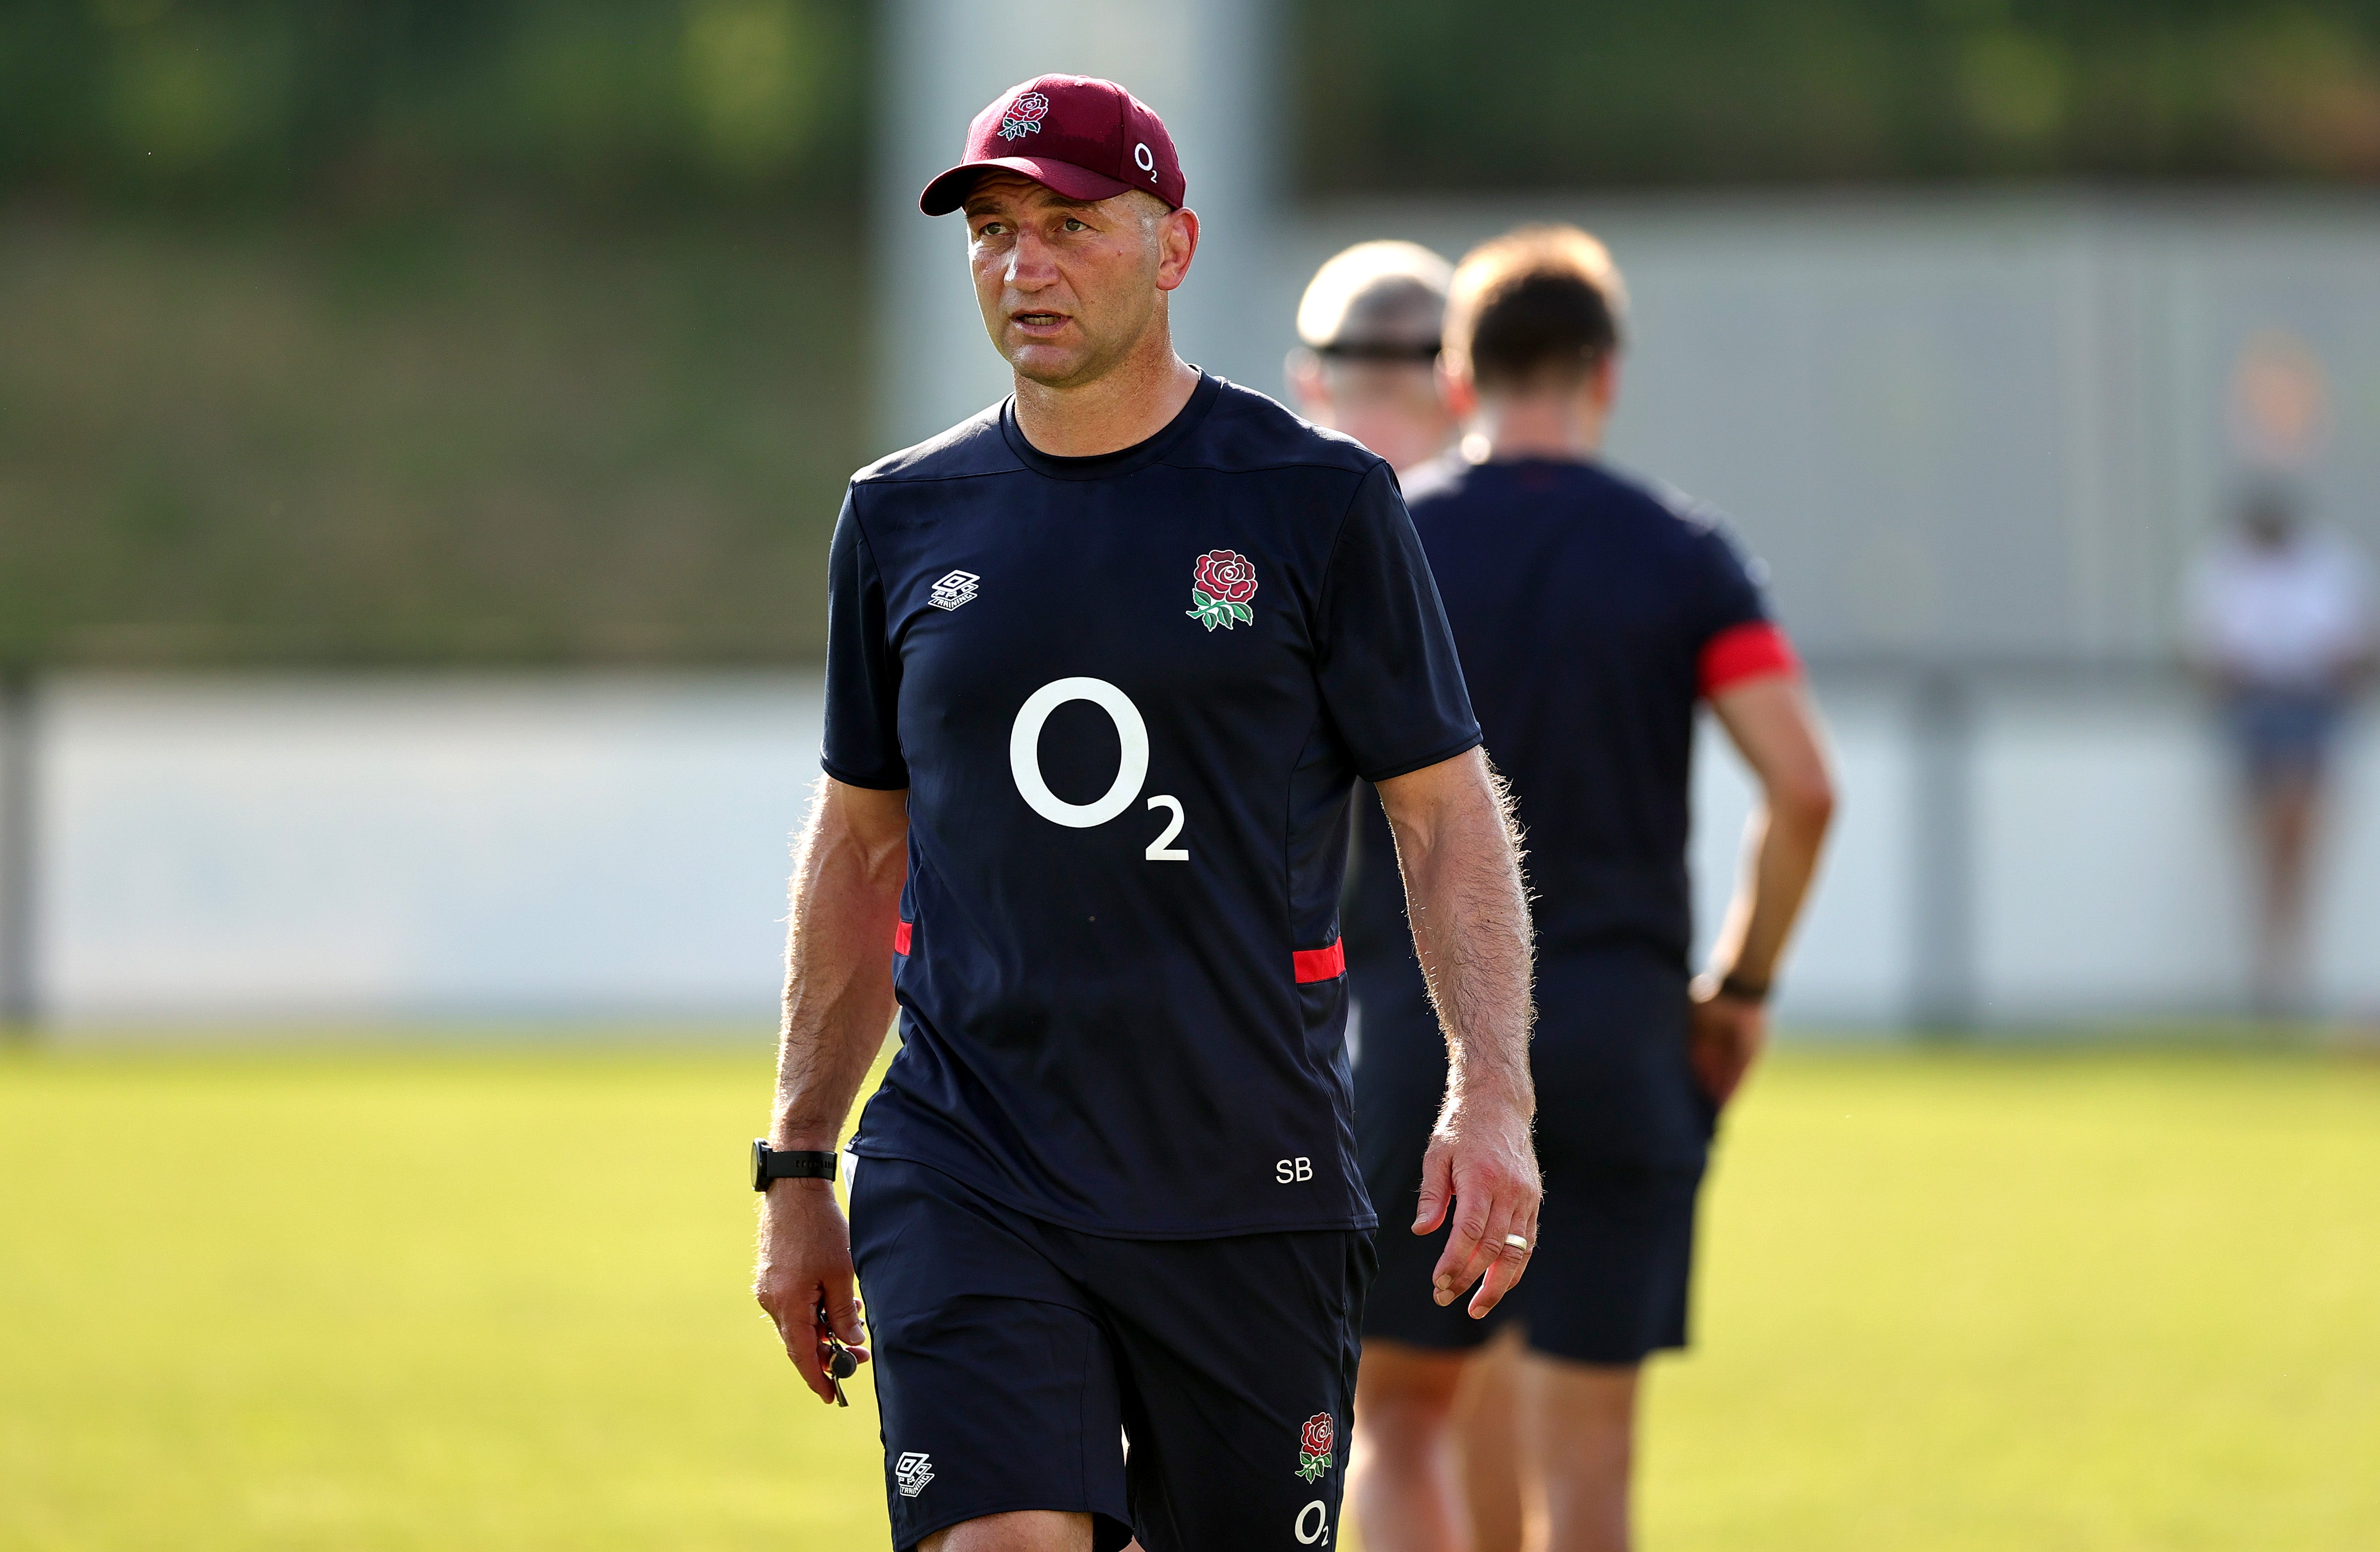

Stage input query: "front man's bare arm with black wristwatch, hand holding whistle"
[{"left": 752, "top": 778, "right": 909, "bottom": 1402}]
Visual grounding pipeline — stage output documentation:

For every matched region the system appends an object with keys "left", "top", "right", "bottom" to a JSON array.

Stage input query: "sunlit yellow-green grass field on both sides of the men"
[{"left": 0, "top": 1042, "right": 2380, "bottom": 1552}]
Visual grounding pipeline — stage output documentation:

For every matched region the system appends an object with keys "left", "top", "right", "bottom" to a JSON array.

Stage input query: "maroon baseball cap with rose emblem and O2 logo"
[{"left": 916, "top": 76, "right": 1185, "bottom": 217}]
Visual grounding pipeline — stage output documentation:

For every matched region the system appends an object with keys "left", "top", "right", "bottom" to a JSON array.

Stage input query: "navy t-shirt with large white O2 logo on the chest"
[{"left": 823, "top": 376, "right": 1478, "bottom": 1238}]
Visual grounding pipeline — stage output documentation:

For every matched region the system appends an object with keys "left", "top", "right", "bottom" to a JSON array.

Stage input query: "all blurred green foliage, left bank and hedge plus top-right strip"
[{"left": 14, "top": 0, "right": 2380, "bottom": 662}]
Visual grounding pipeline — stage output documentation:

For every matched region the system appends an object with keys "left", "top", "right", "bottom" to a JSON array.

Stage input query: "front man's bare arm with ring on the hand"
[{"left": 1378, "top": 750, "right": 1540, "bottom": 1319}]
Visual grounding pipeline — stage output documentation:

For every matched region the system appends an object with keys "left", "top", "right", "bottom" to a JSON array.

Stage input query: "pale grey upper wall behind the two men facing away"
[{"left": 1295, "top": 191, "right": 2380, "bottom": 662}]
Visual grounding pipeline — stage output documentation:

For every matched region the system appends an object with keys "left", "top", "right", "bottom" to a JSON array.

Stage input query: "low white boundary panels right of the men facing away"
[{"left": 1692, "top": 674, "right": 2380, "bottom": 1026}]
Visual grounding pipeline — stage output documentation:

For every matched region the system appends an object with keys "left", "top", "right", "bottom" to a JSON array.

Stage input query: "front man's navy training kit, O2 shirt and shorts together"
[{"left": 823, "top": 376, "right": 1478, "bottom": 1552}]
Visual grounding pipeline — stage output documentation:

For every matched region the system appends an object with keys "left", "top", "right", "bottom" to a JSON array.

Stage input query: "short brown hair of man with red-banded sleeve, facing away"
[{"left": 1444, "top": 226, "right": 1628, "bottom": 390}]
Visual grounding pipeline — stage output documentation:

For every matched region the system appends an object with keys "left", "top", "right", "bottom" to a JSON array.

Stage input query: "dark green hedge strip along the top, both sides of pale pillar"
[{"left": 18, "top": 0, "right": 2380, "bottom": 212}]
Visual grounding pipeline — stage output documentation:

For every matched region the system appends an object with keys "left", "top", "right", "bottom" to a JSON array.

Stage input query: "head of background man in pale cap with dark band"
[{"left": 1288, "top": 243, "right": 1456, "bottom": 474}]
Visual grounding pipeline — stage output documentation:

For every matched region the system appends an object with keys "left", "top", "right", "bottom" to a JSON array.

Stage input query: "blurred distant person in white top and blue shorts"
[{"left": 2190, "top": 486, "right": 2373, "bottom": 1014}]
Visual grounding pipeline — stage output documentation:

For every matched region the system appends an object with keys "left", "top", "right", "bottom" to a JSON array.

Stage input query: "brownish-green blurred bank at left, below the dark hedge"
[{"left": 0, "top": 212, "right": 866, "bottom": 664}]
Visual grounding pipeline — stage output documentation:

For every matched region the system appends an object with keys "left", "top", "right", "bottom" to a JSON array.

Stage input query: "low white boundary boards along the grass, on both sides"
[{"left": 9, "top": 674, "right": 2380, "bottom": 1029}]
